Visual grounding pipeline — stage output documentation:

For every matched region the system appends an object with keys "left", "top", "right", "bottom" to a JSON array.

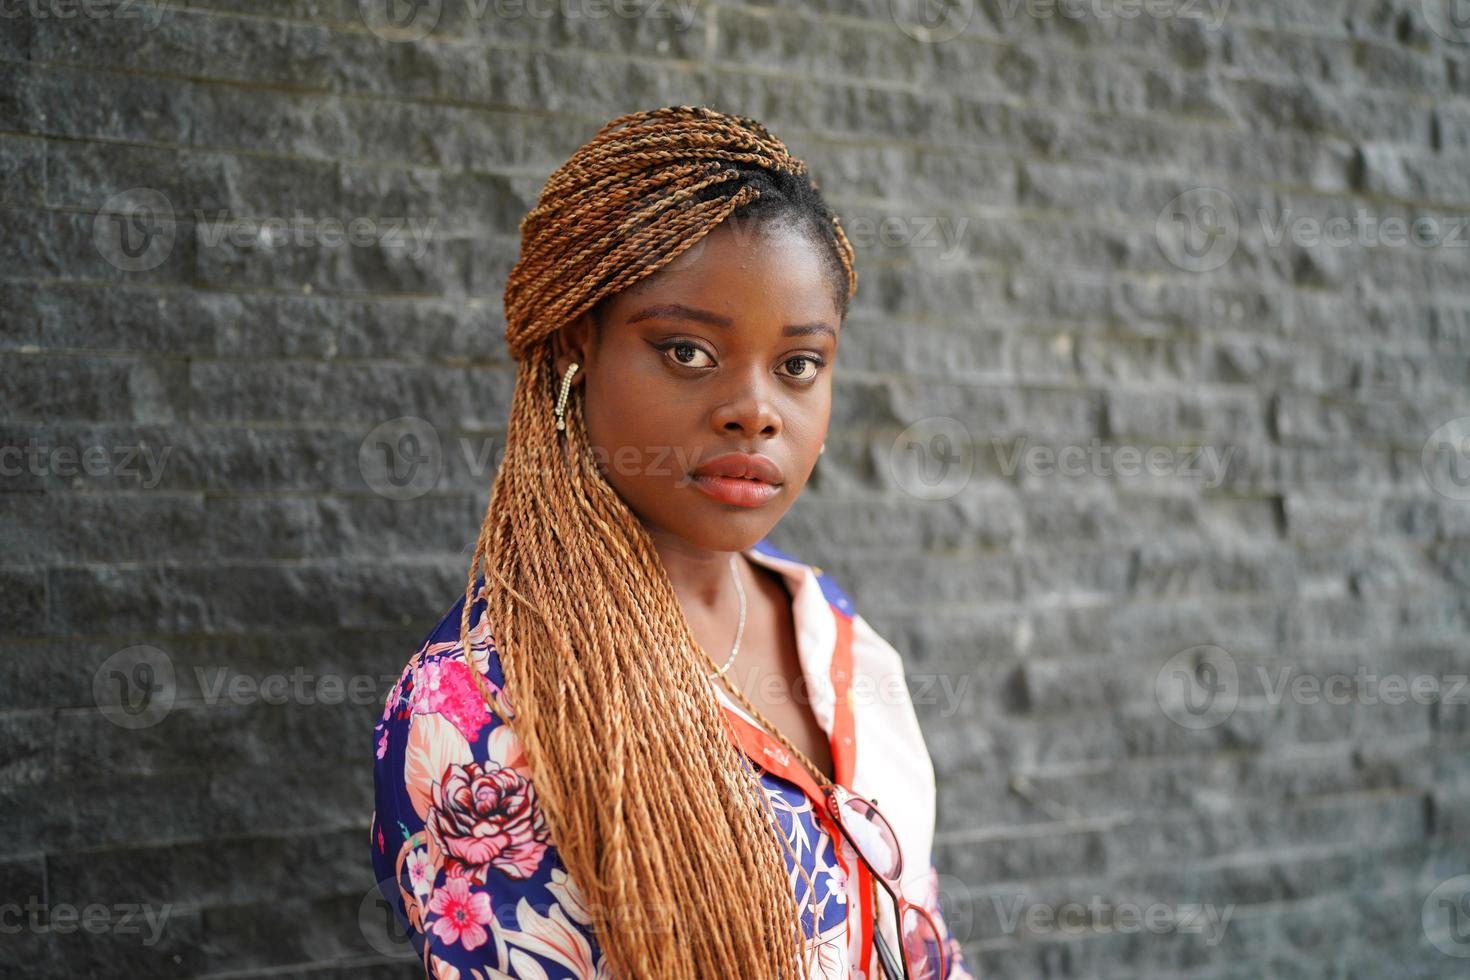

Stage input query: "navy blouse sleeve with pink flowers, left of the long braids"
[{"left": 370, "top": 582, "right": 606, "bottom": 977}]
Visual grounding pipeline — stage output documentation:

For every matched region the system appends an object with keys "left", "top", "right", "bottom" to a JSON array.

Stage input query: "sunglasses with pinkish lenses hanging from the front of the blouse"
[{"left": 822, "top": 783, "right": 948, "bottom": 980}]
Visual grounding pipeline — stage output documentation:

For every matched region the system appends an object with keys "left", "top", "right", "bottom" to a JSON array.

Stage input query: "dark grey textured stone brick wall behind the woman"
[{"left": 0, "top": 0, "right": 1470, "bottom": 980}]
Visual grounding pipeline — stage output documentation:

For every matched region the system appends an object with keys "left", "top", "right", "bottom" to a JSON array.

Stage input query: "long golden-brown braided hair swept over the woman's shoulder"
[{"left": 460, "top": 106, "right": 857, "bottom": 980}]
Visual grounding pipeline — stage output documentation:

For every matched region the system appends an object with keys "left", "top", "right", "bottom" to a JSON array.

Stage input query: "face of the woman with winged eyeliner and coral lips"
[{"left": 557, "top": 222, "right": 841, "bottom": 551}]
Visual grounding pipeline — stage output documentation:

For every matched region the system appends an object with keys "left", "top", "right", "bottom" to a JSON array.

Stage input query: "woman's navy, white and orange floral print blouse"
[{"left": 369, "top": 541, "right": 973, "bottom": 980}]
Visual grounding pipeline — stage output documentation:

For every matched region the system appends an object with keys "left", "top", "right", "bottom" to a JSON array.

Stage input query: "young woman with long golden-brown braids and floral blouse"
[{"left": 370, "top": 106, "right": 970, "bottom": 980}]
